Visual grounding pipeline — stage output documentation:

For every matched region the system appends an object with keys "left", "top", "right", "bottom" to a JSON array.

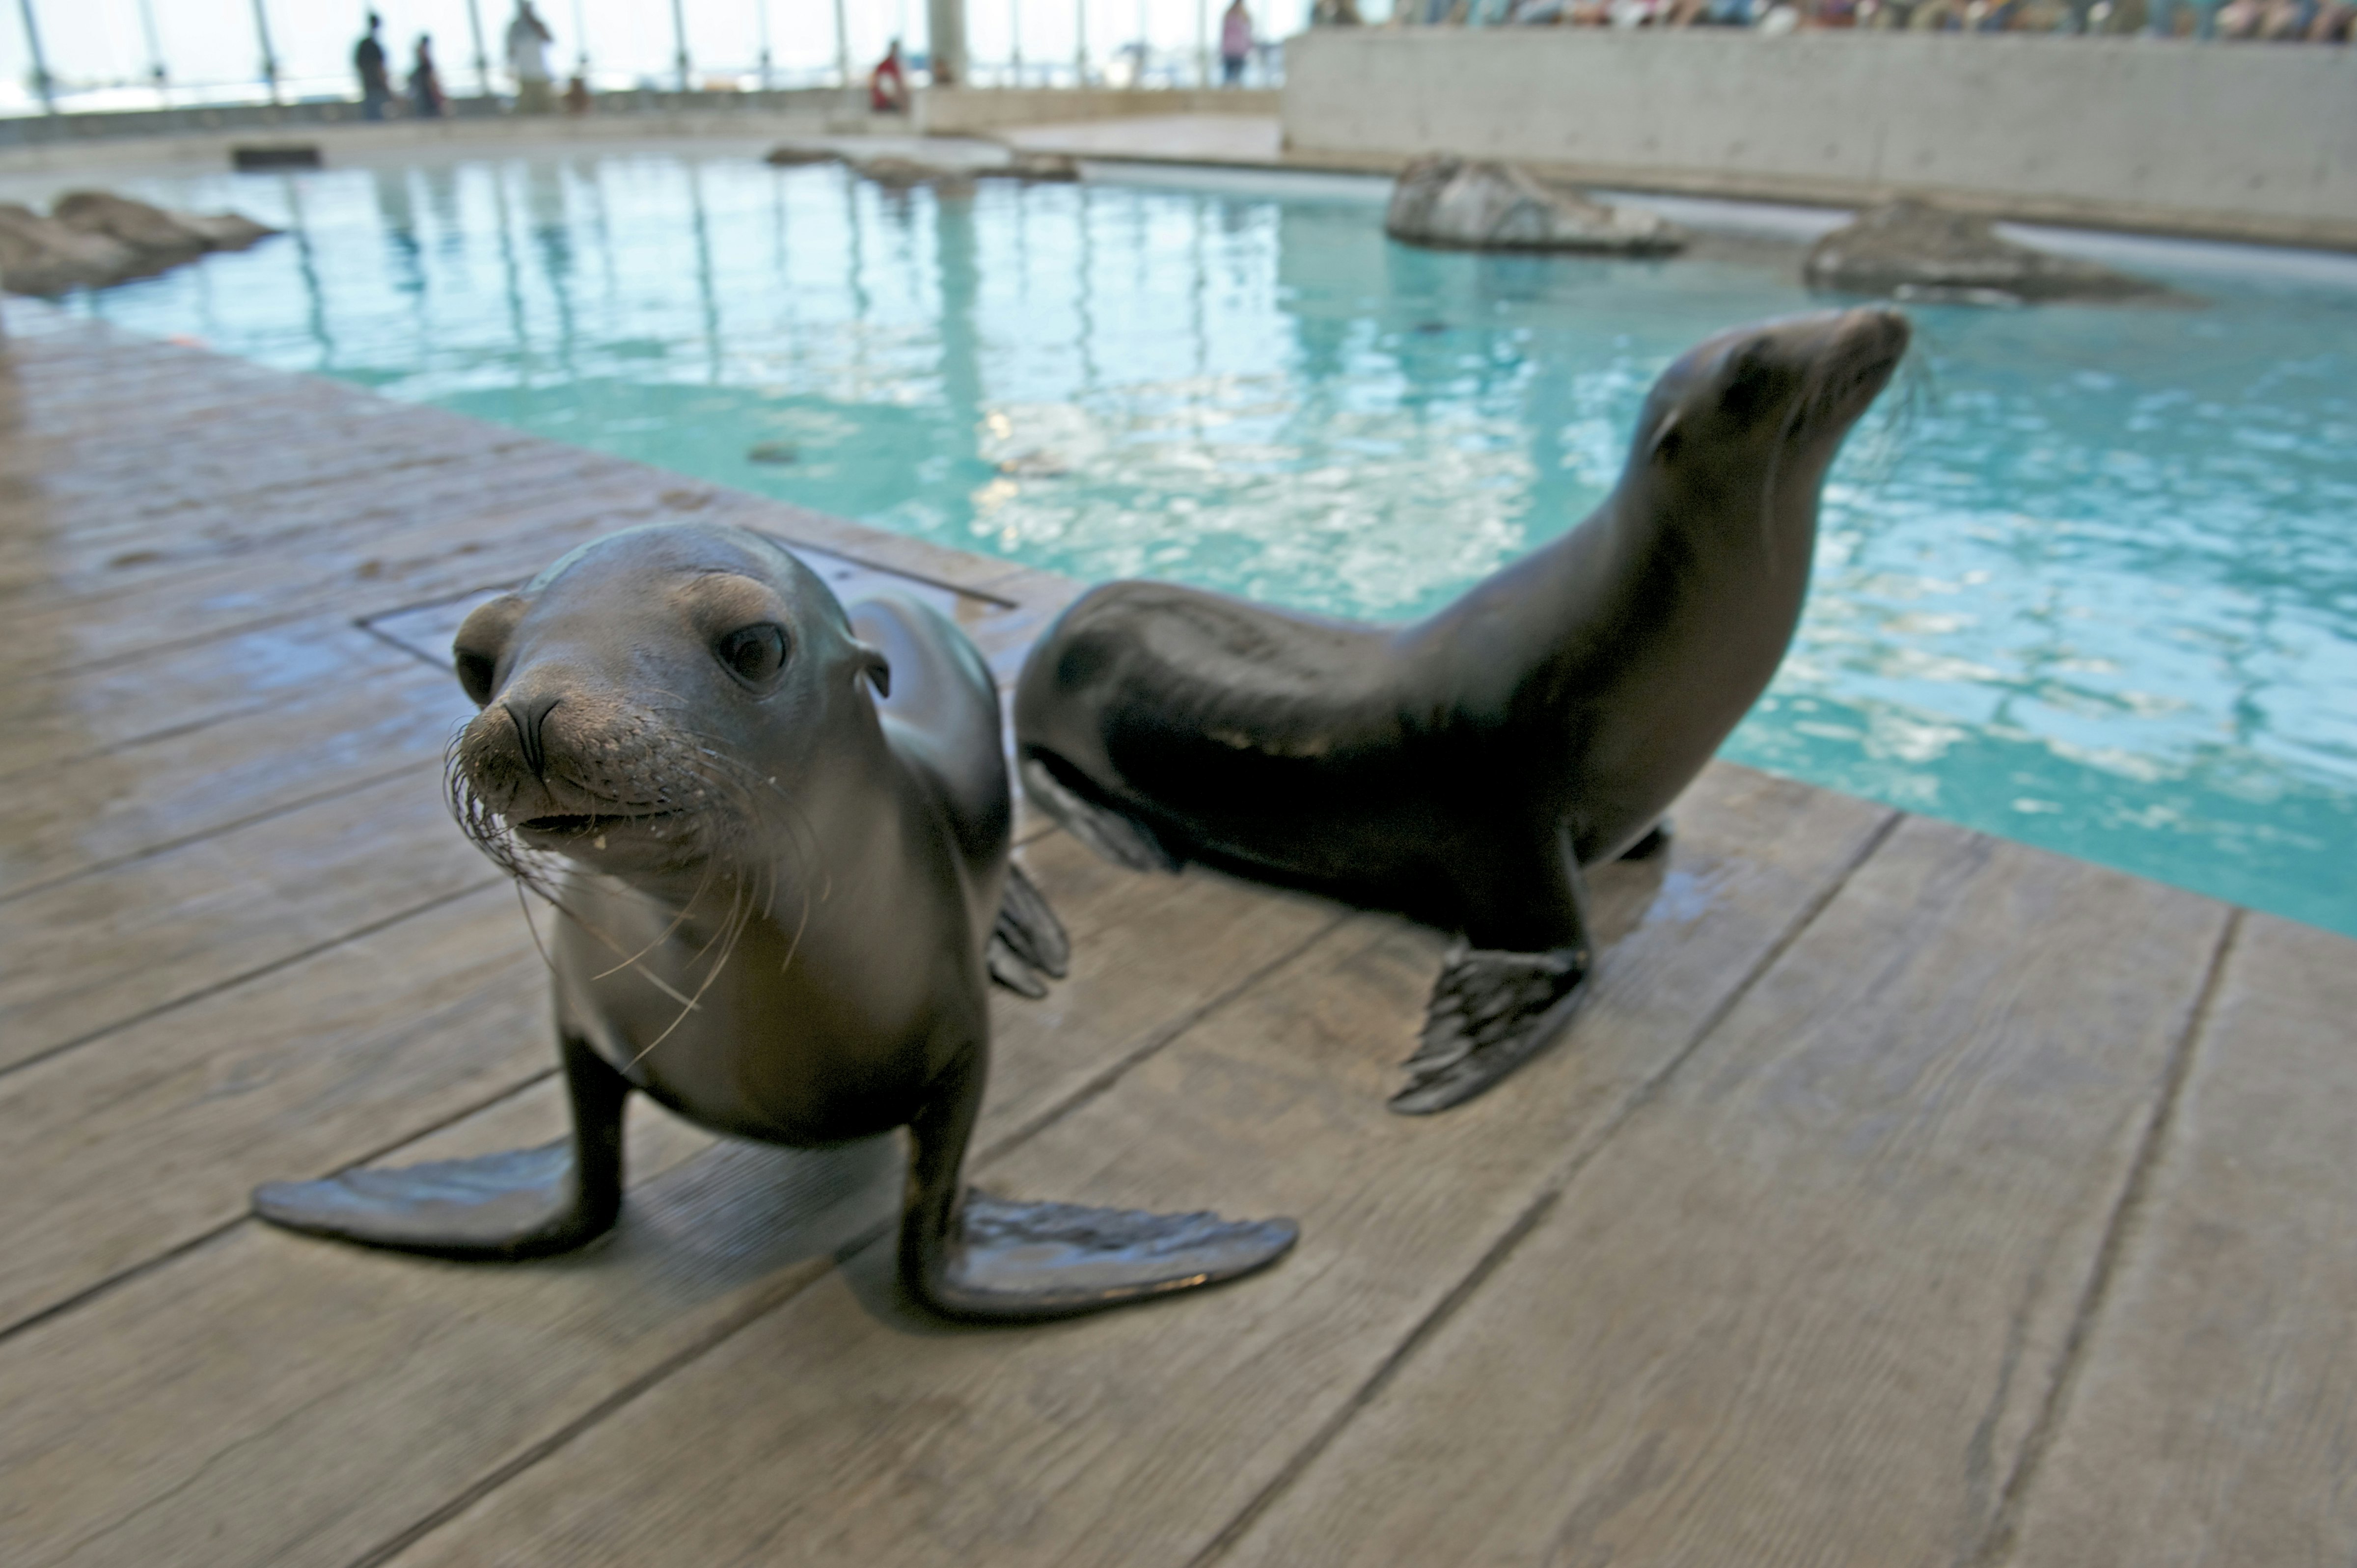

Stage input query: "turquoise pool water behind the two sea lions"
[{"left": 76, "top": 156, "right": 2357, "bottom": 934}]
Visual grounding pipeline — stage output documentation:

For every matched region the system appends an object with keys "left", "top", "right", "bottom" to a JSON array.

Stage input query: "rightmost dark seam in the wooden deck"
[{"left": 1956, "top": 905, "right": 2248, "bottom": 1568}]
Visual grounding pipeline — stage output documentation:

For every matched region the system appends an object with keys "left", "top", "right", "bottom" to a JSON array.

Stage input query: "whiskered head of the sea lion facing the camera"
[{"left": 450, "top": 523, "right": 889, "bottom": 872}]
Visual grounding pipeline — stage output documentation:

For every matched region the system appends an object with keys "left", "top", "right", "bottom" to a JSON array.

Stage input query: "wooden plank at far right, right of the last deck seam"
[{"left": 2010, "top": 915, "right": 2357, "bottom": 1568}]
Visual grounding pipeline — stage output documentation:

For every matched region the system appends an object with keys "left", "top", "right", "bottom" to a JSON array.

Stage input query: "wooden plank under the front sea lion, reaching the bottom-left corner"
[{"left": 0, "top": 837, "right": 1334, "bottom": 1566}]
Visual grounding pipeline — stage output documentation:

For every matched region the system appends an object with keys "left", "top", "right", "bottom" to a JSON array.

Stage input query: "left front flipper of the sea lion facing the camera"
[{"left": 254, "top": 1037, "right": 630, "bottom": 1262}]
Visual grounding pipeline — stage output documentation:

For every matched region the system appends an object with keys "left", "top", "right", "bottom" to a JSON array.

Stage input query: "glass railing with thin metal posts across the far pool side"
[{"left": 0, "top": 0, "right": 1311, "bottom": 115}]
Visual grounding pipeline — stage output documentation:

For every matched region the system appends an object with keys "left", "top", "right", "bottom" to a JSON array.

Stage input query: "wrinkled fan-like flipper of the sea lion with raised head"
[{"left": 1391, "top": 948, "right": 1589, "bottom": 1115}]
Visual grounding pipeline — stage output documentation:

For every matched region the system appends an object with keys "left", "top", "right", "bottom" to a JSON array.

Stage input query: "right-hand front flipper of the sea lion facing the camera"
[{"left": 901, "top": 1052, "right": 1299, "bottom": 1323}]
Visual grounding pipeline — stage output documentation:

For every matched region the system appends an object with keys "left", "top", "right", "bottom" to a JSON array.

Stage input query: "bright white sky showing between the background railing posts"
[{"left": 0, "top": 0, "right": 1308, "bottom": 97}]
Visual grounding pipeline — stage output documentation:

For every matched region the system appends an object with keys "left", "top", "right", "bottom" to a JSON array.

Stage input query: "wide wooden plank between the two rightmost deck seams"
[{"left": 1226, "top": 818, "right": 2227, "bottom": 1568}]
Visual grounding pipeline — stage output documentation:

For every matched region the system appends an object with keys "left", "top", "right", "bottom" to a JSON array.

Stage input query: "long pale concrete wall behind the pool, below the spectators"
[{"left": 1285, "top": 28, "right": 2357, "bottom": 247}]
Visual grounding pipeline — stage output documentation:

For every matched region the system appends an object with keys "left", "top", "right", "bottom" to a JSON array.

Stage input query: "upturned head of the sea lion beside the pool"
[{"left": 1626, "top": 306, "right": 1909, "bottom": 531}]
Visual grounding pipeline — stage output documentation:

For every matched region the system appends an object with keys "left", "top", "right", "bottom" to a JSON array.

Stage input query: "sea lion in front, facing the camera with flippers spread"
[{"left": 254, "top": 526, "right": 1294, "bottom": 1321}]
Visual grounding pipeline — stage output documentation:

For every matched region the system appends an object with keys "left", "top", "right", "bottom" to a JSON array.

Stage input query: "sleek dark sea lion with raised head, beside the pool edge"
[{"left": 1016, "top": 309, "right": 1907, "bottom": 1113}]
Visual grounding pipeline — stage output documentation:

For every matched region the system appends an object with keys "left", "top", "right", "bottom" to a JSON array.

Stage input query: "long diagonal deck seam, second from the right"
[{"left": 1188, "top": 809, "right": 1907, "bottom": 1568}]
